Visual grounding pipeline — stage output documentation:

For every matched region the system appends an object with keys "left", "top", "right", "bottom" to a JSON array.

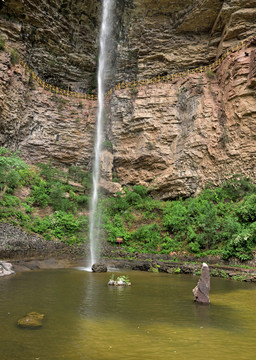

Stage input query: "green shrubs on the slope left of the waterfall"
[{"left": 0, "top": 148, "right": 89, "bottom": 244}]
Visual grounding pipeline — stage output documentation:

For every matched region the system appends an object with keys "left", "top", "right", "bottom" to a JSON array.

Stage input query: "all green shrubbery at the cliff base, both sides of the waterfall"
[{"left": 0, "top": 148, "right": 256, "bottom": 261}]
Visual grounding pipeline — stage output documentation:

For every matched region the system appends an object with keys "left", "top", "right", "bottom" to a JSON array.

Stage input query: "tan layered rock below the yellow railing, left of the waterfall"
[{"left": 0, "top": 48, "right": 97, "bottom": 166}]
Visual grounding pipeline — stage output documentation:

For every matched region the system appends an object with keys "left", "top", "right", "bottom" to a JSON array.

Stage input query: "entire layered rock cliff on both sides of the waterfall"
[{"left": 0, "top": 0, "right": 256, "bottom": 199}]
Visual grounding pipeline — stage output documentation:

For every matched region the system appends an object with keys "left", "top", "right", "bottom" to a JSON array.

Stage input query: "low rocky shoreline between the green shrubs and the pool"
[{"left": 0, "top": 223, "right": 256, "bottom": 282}]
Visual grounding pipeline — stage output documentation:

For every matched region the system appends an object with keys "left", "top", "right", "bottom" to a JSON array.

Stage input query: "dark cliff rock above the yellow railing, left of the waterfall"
[{"left": 0, "top": 0, "right": 100, "bottom": 91}]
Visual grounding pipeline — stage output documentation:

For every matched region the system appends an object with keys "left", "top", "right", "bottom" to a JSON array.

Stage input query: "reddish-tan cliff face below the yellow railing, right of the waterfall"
[{"left": 109, "top": 42, "right": 256, "bottom": 199}]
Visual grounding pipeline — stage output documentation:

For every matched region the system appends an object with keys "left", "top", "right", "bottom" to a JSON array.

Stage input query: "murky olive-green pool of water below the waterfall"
[{"left": 0, "top": 269, "right": 256, "bottom": 360}]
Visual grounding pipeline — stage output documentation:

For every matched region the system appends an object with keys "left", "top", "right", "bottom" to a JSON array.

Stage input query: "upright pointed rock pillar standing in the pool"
[{"left": 193, "top": 263, "right": 210, "bottom": 304}]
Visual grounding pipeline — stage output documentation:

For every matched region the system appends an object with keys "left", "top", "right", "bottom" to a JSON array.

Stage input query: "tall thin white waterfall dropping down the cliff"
[{"left": 89, "top": 0, "right": 115, "bottom": 268}]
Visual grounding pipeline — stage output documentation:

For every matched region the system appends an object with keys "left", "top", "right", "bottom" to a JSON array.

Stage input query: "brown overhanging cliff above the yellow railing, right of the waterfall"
[{"left": 117, "top": 0, "right": 256, "bottom": 80}]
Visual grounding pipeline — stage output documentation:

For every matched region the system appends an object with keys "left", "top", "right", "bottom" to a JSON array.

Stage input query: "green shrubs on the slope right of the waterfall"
[{"left": 103, "top": 176, "right": 256, "bottom": 261}]
